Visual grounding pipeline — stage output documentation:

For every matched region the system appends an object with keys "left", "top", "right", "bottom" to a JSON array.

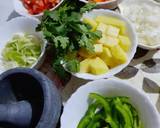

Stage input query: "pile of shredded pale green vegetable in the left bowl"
[{"left": 2, "top": 34, "right": 41, "bottom": 67}]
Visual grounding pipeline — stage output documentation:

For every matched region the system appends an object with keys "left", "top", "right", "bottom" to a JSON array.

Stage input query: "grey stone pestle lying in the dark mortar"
[{"left": 0, "top": 101, "right": 32, "bottom": 127}]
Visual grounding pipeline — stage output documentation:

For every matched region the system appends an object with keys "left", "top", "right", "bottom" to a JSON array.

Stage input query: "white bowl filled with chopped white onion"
[{"left": 119, "top": 0, "right": 160, "bottom": 50}]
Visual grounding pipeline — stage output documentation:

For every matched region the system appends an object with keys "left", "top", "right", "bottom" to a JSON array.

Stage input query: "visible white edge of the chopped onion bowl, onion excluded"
[{"left": 119, "top": 0, "right": 160, "bottom": 50}]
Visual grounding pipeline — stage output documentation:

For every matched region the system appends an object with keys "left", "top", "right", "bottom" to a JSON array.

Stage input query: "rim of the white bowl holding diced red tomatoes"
[{"left": 13, "top": 0, "right": 64, "bottom": 18}]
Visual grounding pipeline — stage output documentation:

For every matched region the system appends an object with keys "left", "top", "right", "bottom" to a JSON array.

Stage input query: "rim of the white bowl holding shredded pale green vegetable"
[{"left": 2, "top": 16, "right": 48, "bottom": 70}]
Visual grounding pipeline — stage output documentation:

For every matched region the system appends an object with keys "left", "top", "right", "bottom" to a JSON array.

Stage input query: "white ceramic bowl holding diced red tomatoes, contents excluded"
[{"left": 13, "top": 0, "right": 64, "bottom": 18}]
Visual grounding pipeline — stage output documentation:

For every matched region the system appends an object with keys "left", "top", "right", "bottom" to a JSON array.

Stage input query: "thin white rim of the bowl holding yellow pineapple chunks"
[{"left": 71, "top": 9, "right": 138, "bottom": 80}]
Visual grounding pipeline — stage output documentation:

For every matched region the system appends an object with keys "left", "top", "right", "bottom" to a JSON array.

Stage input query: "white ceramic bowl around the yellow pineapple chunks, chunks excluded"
[{"left": 73, "top": 9, "right": 138, "bottom": 80}]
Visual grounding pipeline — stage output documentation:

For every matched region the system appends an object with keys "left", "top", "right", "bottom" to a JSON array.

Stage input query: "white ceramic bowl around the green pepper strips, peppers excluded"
[{"left": 61, "top": 79, "right": 160, "bottom": 128}]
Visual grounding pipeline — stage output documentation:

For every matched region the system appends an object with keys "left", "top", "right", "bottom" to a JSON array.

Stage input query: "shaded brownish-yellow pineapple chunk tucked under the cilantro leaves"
[{"left": 78, "top": 48, "right": 95, "bottom": 58}]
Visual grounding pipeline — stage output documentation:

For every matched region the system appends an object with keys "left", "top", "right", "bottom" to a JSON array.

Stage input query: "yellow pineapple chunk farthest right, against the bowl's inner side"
[{"left": 119, "top": 36, "right": 131, "bottom": 52}]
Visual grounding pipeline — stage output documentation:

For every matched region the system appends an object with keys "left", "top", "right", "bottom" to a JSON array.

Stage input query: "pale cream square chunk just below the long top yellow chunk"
[{"left": 106, "top": 25, "right": 120, "bottom": 37}]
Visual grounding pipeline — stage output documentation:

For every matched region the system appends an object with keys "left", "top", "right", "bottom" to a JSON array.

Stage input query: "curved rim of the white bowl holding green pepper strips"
[{"left": 60, "top": 77, "right": 160, "bottom": 126}]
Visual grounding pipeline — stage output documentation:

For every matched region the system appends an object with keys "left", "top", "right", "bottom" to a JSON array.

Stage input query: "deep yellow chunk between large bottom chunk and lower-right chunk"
[{"left": 99, "top": 47, "right": 118, "bottom": 68}]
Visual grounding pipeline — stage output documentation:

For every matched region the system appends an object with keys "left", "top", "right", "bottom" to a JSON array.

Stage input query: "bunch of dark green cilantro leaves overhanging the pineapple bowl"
[{"left": 36, "top": 0, "right": 101, "bottom": 77}]
